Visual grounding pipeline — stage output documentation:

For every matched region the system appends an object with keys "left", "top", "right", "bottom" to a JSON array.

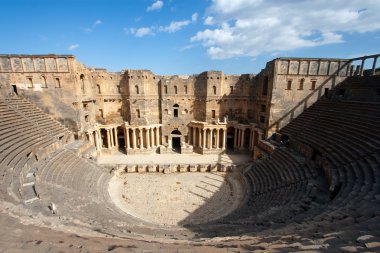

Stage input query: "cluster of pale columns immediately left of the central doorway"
[{"left": 124, "top": 124, "right": 161, "bottom": 150}]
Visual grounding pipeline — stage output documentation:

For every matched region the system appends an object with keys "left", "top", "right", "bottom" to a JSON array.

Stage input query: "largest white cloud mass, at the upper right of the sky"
[{"left": 191, "top": 0, "right": 380, "bottom": 59}]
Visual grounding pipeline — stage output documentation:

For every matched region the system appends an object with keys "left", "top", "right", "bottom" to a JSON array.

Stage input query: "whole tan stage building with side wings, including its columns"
[{"left": 0, "top": 55, "right": 377, "bottom": 159}]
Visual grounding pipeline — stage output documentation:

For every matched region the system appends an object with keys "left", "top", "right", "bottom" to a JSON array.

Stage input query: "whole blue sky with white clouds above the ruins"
[{"left": 0, "top": 0, "right": 380, "bottom": 75}]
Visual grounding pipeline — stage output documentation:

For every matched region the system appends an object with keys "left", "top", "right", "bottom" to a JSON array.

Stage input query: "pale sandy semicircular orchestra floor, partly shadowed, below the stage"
[{"left": 109, "top": 173, "right": 243, "bottom": 226}]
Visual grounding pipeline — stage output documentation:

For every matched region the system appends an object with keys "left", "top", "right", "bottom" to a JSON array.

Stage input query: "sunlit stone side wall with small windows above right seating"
[{"left": 266, "top": 58, "right": 349, "bottom": 135}]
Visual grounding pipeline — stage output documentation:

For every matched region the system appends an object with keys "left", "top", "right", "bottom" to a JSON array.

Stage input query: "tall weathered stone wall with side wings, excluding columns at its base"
[{"left": 0, "top": 55, "right": 350, "bottom": 143}]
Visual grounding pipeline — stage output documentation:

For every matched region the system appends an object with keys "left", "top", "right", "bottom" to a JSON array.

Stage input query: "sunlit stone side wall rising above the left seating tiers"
[{"left": 0, "top": 55, "right": 98, "bottom": 132}]
